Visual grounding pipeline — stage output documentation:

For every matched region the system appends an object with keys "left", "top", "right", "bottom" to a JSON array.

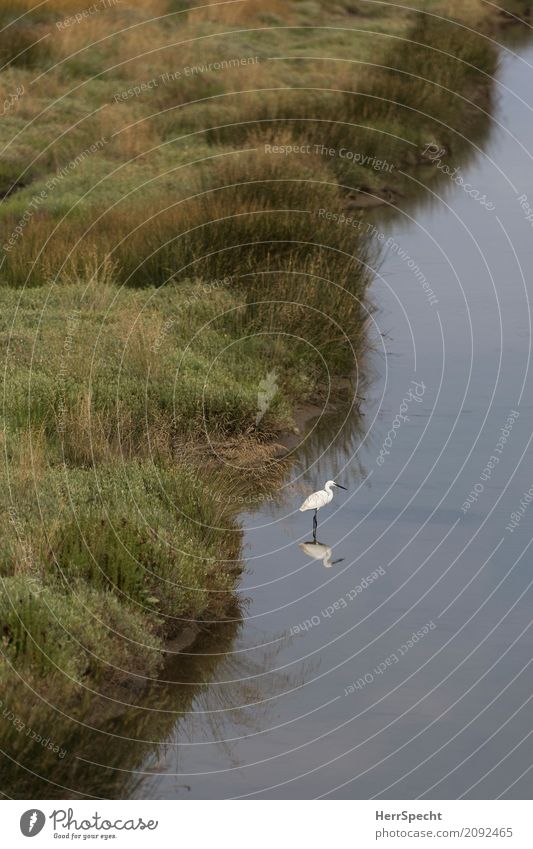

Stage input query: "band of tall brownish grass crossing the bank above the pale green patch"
[{"left": 5, "top": 134, "right": 358, "bottom": 285}]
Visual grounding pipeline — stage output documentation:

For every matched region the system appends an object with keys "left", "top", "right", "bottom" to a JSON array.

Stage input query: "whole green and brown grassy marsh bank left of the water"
[{"left": 0, "top": 0, "right": 516, "bottom": 693}]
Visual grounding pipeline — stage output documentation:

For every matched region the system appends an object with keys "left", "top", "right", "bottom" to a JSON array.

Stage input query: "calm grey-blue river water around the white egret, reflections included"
[{"left": 7, "top": 26, "right": 533, "bottom": 799}]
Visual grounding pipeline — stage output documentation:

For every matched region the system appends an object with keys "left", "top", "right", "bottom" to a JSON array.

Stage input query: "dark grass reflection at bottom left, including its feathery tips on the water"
[{"left": 0, "top": 621, "right": 300, "bottom": 799}]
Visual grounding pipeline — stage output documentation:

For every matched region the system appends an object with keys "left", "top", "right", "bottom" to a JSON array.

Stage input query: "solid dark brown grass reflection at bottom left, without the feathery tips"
[{"left": 0, "top": 621, "right": 239, "bottom": 798}]
